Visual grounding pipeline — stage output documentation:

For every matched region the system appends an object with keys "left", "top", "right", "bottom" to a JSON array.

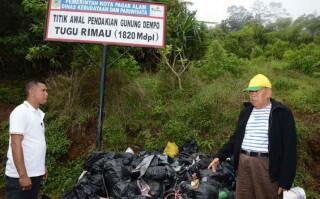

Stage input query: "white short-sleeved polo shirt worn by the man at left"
[{"left": 5, "top": 101, "right": 46, "bottom": 178}]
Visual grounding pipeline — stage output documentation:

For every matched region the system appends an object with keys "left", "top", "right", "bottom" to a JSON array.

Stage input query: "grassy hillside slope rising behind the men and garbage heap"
[{"left": 0, "top": 60, "right": 320, "bottom": 198}]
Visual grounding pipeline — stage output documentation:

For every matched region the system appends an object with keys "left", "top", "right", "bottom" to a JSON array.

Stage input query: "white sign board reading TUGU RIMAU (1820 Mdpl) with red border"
[{"left": 45, "top": 0, "right": 166, "bottom": 48}]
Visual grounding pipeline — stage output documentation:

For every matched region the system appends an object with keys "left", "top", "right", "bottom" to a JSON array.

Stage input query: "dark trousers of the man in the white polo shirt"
[{"left": 6, "top": 176, "right": 43, "bottom": 199}]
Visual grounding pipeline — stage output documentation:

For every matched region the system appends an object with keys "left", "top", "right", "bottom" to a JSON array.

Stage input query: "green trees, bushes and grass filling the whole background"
[{"left": 0, "top": 0, "right": 320, "bottom": 198}]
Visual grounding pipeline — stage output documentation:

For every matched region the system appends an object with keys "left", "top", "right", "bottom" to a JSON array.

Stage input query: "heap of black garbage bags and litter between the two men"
[{"left": 63, "top": 140, "right": 235, "bottom": 199}]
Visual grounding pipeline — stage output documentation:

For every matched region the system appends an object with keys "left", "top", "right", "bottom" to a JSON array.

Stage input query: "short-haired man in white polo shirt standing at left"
[{"left": 5, "top": 81, "right": 48, "bottom": 199}]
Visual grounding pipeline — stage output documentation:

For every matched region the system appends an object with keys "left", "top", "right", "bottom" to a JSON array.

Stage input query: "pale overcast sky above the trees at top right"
[{"left": 188, "top": 0, "right": 320, "bottom": 22}]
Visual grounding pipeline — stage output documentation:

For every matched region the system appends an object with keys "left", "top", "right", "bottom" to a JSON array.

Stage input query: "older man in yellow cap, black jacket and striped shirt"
[{"left": 209, "top": 74, "right": 296, "bottom": 199}]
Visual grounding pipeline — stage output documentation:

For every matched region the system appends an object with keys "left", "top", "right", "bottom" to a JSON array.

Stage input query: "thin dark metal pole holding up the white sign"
[{"left": 96, "top": 45, "right": 108, "bottom": 151}]
